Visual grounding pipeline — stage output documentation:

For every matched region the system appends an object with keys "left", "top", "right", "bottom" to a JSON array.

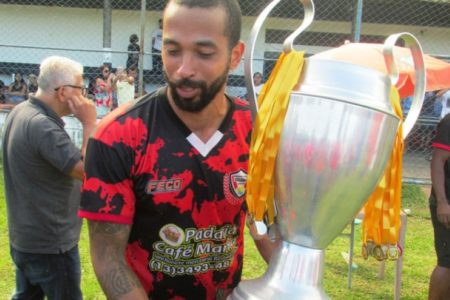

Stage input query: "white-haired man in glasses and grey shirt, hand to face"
[{"left": 3, "top": 56, "right": 96, "bottom": 300}]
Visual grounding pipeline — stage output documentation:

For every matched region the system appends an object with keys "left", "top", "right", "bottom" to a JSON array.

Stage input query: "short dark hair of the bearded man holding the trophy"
[{"left": 167, "top": 0, "right": 242, "bottom": 50}]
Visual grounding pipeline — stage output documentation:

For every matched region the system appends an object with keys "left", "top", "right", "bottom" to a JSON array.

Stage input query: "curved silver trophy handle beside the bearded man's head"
[{"left": 244, "top": 0, "right": 314, "bottom": 122}]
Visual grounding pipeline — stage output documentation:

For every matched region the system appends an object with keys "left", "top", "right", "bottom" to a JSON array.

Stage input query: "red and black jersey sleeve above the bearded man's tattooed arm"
[{"left": 78, "top": 130, "right": 135, "bottom": 224}]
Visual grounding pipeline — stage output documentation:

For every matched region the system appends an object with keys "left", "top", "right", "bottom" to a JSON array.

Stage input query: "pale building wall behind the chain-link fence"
[{"left": 0, "top": 4, "right": 450, "bottom": 86}]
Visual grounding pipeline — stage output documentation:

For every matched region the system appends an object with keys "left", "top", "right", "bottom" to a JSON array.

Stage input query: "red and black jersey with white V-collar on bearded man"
[{"left": 79, "top": 88, "right": 252, "bottom": 299}]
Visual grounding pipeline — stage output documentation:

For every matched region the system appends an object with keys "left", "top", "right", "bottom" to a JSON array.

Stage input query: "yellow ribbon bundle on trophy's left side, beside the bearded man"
[{"left": 247, "top": 50, "right": 304, "bottom": 224}]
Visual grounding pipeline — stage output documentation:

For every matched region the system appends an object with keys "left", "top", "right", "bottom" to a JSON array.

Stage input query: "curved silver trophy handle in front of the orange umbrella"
[{"left": 383, "top": 32, "right": 426, "bottom": 139}]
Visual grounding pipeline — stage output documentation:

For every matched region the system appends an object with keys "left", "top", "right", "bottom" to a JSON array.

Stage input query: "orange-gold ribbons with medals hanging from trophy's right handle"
[{"left": 362, "top": 87, "right": 404, "bottom": 260}]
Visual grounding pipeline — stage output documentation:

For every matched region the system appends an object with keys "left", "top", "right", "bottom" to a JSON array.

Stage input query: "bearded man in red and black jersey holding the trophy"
[{"left": 79, "top": 0, "right": 274, "bottom": 299}]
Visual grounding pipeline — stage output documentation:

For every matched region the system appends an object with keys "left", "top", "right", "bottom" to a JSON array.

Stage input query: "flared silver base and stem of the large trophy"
[{"left": 228, "top": 241, "right": 329, "bottom": 300}]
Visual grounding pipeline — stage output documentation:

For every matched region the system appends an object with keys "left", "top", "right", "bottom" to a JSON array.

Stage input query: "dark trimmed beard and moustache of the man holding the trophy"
[{"left": 164, "top": 66, "right": 230, "bottom": 112}]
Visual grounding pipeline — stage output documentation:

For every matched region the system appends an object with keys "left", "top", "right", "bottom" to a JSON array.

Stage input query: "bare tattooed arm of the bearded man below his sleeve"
[{"left": 89, "top": 221, "right": 142, "bottom": 299}]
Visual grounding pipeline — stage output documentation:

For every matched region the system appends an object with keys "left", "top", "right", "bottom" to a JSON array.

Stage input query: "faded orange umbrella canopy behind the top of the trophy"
[{"left": 315, "top": 43, "right": 450, "bottom": 98}]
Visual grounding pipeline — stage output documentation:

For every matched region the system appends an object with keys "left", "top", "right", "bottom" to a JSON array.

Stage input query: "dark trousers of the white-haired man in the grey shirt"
[{"left": 11, "top": 246, "right": 83, "bottom": 300}]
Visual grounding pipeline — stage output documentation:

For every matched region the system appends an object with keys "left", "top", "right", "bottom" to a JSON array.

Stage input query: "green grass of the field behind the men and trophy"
[{"left": 0, "top": 178, "right": 435, "bottom": 300}]
